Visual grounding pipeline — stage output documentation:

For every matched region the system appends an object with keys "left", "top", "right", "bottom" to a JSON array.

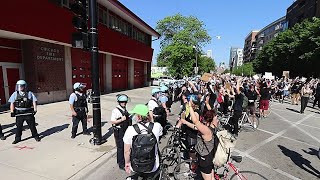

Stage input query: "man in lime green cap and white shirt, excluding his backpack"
[{"left": 123, "top": 104, "right": 162, "bottom": 180}]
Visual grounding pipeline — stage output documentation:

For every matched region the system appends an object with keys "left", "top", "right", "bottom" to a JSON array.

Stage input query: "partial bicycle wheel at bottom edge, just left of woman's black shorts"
[{"left": 173, "top": 160, "right": 196, "bottom": 180}]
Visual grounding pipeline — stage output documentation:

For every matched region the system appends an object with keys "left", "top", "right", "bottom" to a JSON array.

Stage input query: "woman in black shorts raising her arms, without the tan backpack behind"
[{"left": 180, "top": 107, "right": 218, "bottom": 180}]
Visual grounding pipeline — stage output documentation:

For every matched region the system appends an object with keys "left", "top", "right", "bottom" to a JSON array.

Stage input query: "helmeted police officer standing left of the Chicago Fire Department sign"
[{"left": 9, "top": 80, "right": 41, "bottom": 144}]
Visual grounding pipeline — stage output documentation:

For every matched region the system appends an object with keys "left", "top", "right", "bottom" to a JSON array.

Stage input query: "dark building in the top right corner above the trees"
[{"left": 286, "top": 0, "right": 320, "bottom": 28}]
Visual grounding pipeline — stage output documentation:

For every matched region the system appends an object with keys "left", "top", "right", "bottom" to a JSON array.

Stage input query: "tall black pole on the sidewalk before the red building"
[{"left": 89, "top": 0, "right": 102, "bottom": 145}]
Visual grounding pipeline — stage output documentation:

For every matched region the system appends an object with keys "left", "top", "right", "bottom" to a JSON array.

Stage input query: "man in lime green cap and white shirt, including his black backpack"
[{"left": 123, "top": 104, "right": 162, "bottom": 180}]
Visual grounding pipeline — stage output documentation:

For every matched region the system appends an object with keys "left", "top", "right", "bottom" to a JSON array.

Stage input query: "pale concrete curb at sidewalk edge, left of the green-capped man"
[{"left": 67, "top": 148, "right": 117, "bottom": 180}]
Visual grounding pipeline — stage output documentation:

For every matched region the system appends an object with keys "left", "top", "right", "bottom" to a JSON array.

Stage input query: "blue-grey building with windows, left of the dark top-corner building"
[{"left": 255, "top": 16, "right": 288, "bottom": 57}]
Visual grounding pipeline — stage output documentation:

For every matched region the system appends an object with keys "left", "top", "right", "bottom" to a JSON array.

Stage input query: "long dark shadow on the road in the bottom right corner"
[{"left": 278, "top": 145, "right": 320, "bottom": 178}]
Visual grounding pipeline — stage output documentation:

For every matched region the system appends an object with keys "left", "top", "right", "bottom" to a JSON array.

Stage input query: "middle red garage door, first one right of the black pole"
[{"left": 112, "top": 56, "right": 128, "bottom": 90}]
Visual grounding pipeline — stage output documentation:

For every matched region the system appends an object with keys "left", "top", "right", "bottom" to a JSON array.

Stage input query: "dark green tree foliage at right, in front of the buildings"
[{"left": 253, "top": 18, "right": 320, "bottom": 76}]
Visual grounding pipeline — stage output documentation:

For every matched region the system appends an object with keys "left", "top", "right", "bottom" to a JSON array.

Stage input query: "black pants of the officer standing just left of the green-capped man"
[{"left": 113, "top": 127, "right": 126, "bottom": 168}]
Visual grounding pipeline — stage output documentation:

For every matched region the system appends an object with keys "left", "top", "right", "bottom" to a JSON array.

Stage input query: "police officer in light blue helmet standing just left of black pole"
[{"left": 69, "top": 82, "right": 90, "bottom": 139}]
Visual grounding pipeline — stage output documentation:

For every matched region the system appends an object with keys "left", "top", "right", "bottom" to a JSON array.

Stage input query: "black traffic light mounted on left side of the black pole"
[{"left": 70, "top": 0, "right": 89, "bottom": 49}]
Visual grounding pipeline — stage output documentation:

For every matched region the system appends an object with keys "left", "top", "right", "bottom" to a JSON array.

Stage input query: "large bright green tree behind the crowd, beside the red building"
[{"left": 156, "top": 14, "right": 212, "bottom": 77}]
